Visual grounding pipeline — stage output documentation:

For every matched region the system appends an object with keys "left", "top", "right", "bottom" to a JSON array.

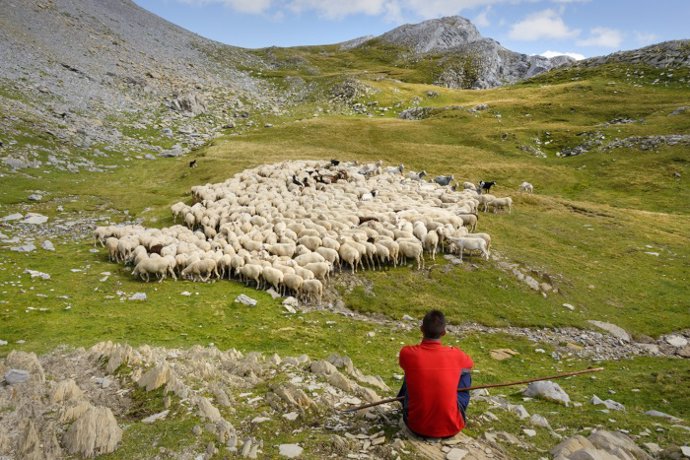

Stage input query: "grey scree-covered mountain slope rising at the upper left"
[{"left": 0, "top": 0, "right": 273, "bottom": 169}]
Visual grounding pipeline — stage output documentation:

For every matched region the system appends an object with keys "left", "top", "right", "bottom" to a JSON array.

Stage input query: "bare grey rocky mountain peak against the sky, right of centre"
[{"left": 379, "top": 16, "right": 483, "bottom": 53}]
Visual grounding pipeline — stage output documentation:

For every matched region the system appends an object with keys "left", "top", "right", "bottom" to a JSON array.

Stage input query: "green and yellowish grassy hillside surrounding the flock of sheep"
[{"left": 0, "top": 57, "right": 690, "bottom": 458}]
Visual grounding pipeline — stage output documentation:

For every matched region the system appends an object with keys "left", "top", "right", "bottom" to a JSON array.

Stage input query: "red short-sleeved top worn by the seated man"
[{"left": 399, "top": 339, "right": 474, "bottom": 438}]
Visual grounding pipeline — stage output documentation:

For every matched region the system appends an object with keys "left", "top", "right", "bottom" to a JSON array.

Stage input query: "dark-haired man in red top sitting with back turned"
[{"left": 398, "top": 310, "right": 474, "bottom": 438}]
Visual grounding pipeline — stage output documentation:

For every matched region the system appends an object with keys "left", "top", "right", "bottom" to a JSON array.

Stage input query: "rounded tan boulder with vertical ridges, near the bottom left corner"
[{"left": 63, "top": 406, "right": 122, "bottom": 458}]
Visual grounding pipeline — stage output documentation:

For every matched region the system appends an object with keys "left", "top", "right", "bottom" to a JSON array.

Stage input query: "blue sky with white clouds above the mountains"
[{"left": 134, "top": 0, "right": 690, "bottom": 59}]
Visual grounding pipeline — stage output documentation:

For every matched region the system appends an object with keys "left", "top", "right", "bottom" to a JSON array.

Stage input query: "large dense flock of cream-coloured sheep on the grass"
[{"left": 95, "top": 160, "right": 512, "bottom": 302}]
